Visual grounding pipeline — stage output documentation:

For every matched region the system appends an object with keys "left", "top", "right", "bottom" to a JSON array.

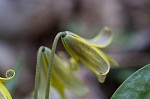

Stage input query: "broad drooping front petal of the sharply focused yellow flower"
[{"left": 62, "top": 32, "right": 110, "bottom": 82}]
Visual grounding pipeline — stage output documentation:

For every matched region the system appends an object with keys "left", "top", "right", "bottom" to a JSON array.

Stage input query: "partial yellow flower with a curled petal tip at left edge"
[{"left": 0, "top": 69, "right": 15, "bottom": 99}]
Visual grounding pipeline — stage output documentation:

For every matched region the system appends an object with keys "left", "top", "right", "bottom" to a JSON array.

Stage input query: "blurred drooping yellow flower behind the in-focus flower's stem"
[{"left": 37, "top": 46, "right": 88, "bottom": 99}]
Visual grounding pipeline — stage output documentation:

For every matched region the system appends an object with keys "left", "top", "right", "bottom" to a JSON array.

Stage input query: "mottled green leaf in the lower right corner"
[{"left": 111, "top": 64, "right": 150, "bottom": 99}]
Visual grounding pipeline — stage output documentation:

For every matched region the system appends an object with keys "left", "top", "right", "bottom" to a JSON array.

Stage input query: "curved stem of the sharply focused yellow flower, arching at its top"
[{"left": 45, "top": 32, "right": 66, "bottom": 99}]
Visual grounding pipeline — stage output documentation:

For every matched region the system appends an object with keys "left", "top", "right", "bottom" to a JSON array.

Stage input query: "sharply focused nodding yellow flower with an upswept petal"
[{"left": 62, "top": 28, "right": 117, "bottom": 83}]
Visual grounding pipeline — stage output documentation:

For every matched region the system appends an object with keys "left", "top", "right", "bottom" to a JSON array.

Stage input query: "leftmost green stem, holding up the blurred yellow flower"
[{"left": 34, "top": 47, "right": 43, "bottom": 99}]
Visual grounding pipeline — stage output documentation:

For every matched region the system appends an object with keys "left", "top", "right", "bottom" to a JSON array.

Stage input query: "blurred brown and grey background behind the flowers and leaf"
[{"left": 0, "top": 0, "right": 150, "bottom": 99}]
